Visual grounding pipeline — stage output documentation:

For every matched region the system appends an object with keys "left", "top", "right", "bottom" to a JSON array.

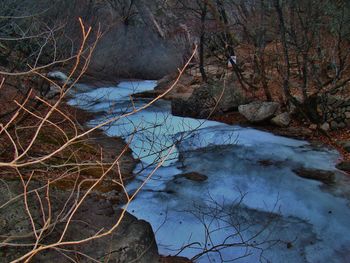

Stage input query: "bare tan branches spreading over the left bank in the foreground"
[{"left": 0, "top": 9, "right": 198, "bottom": 262}]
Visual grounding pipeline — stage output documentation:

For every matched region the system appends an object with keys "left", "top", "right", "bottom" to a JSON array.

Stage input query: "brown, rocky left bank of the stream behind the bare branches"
[{"left": 0, "top": 82, "right": 167, "bottom": 263}]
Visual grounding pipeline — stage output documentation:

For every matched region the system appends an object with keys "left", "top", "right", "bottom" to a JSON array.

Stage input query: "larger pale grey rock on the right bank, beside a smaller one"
[{"left": 238, "top": 101, "right": 279, "bottom": 123}]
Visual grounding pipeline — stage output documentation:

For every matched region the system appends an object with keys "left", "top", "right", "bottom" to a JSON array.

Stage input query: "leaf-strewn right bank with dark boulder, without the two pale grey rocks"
[{"left": 133, "top": 72, "right": 350, "bottom": 174}]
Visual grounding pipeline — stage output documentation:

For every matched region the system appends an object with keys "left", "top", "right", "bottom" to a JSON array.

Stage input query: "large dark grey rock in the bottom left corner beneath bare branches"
[{"left": 0, "top": 180, "right": 159, "bottom": 263}]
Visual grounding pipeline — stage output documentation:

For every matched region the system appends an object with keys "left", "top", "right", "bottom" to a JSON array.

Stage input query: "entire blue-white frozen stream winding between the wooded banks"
[{"left": 70, "top": 81, "right": 350, "bottom": 262}]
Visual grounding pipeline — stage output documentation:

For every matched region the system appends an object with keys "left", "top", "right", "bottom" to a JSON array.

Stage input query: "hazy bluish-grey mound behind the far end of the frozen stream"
[{"left": 87, "top": 23, "right": 184, "bottom": 80}]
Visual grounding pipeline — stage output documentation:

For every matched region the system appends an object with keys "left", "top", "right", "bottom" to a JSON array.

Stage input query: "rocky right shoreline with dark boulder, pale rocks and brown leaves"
[{"left": 133, "top": 73, "right": 350, "bottom": 174}]
